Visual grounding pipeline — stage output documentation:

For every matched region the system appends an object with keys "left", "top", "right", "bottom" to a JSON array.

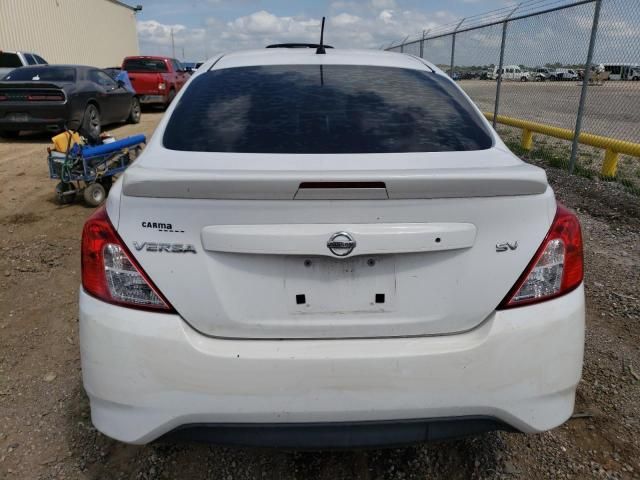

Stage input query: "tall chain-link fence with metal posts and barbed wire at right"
[{"left": 388, "top": 0, "right": 640, "bottom": 193}]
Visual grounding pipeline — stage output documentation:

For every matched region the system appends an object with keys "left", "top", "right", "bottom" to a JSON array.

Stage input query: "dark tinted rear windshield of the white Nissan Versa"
[{"left": 164, "top": 65, "right": 492, "bottom": 154}]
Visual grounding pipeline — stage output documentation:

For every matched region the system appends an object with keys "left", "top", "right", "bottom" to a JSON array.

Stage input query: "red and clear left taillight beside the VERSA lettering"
[{"left": 82, "top": 207, "right": 175, "bottom": 312}]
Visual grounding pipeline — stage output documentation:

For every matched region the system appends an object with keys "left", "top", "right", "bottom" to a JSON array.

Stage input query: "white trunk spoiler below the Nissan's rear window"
[{"left": 123, "top": 163, "right": 548, "bottom": 200}]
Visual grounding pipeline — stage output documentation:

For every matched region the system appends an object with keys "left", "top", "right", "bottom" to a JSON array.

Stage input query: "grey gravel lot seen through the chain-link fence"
[{"left": 459, "top": 80, "right": 640, "bottom": 143}]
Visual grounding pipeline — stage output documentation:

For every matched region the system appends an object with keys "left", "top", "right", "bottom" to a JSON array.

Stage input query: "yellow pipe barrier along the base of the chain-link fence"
[{"left": 484, "top": 112, "right": 640, "bottom": 177}]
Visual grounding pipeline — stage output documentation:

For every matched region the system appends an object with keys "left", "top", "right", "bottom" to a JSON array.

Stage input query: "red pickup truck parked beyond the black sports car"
[{"left": 122, "top": 56, "right": 189, "bottom": 108}]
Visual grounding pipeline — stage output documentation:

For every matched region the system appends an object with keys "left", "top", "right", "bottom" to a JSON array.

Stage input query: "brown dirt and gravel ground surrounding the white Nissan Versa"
[{"left": 0, "top": 113, "right": 640, "bottom": 480}]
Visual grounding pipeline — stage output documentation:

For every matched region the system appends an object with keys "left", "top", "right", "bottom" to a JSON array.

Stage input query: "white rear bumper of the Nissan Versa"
[{"left": 80, "top": 286, "right": 584, "bottom": 447}]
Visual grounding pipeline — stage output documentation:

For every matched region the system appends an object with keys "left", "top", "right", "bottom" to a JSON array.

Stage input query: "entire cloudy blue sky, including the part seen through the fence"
[{"left": 132, "top": 0, "right": 640, "bottom": 67}]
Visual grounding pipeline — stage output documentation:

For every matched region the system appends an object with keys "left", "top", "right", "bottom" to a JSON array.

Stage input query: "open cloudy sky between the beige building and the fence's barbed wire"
[{"left": 134, "top": 0, "right": 514, "bottom": 61}]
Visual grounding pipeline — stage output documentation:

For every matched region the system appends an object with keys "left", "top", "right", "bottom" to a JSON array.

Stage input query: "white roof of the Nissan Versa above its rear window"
[{"left": 206, "top": 48, "right": 439, "bottom": 71}]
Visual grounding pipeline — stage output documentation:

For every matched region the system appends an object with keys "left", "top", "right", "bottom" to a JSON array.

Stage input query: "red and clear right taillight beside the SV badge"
[{"left": 498, "top": 204, "right": 583, "bottom": 309}]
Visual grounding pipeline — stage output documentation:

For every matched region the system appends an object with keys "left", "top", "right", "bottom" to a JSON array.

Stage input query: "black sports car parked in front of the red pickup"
[{"left": 0, "top": 65, "right": 141, "bottom": 137}]
